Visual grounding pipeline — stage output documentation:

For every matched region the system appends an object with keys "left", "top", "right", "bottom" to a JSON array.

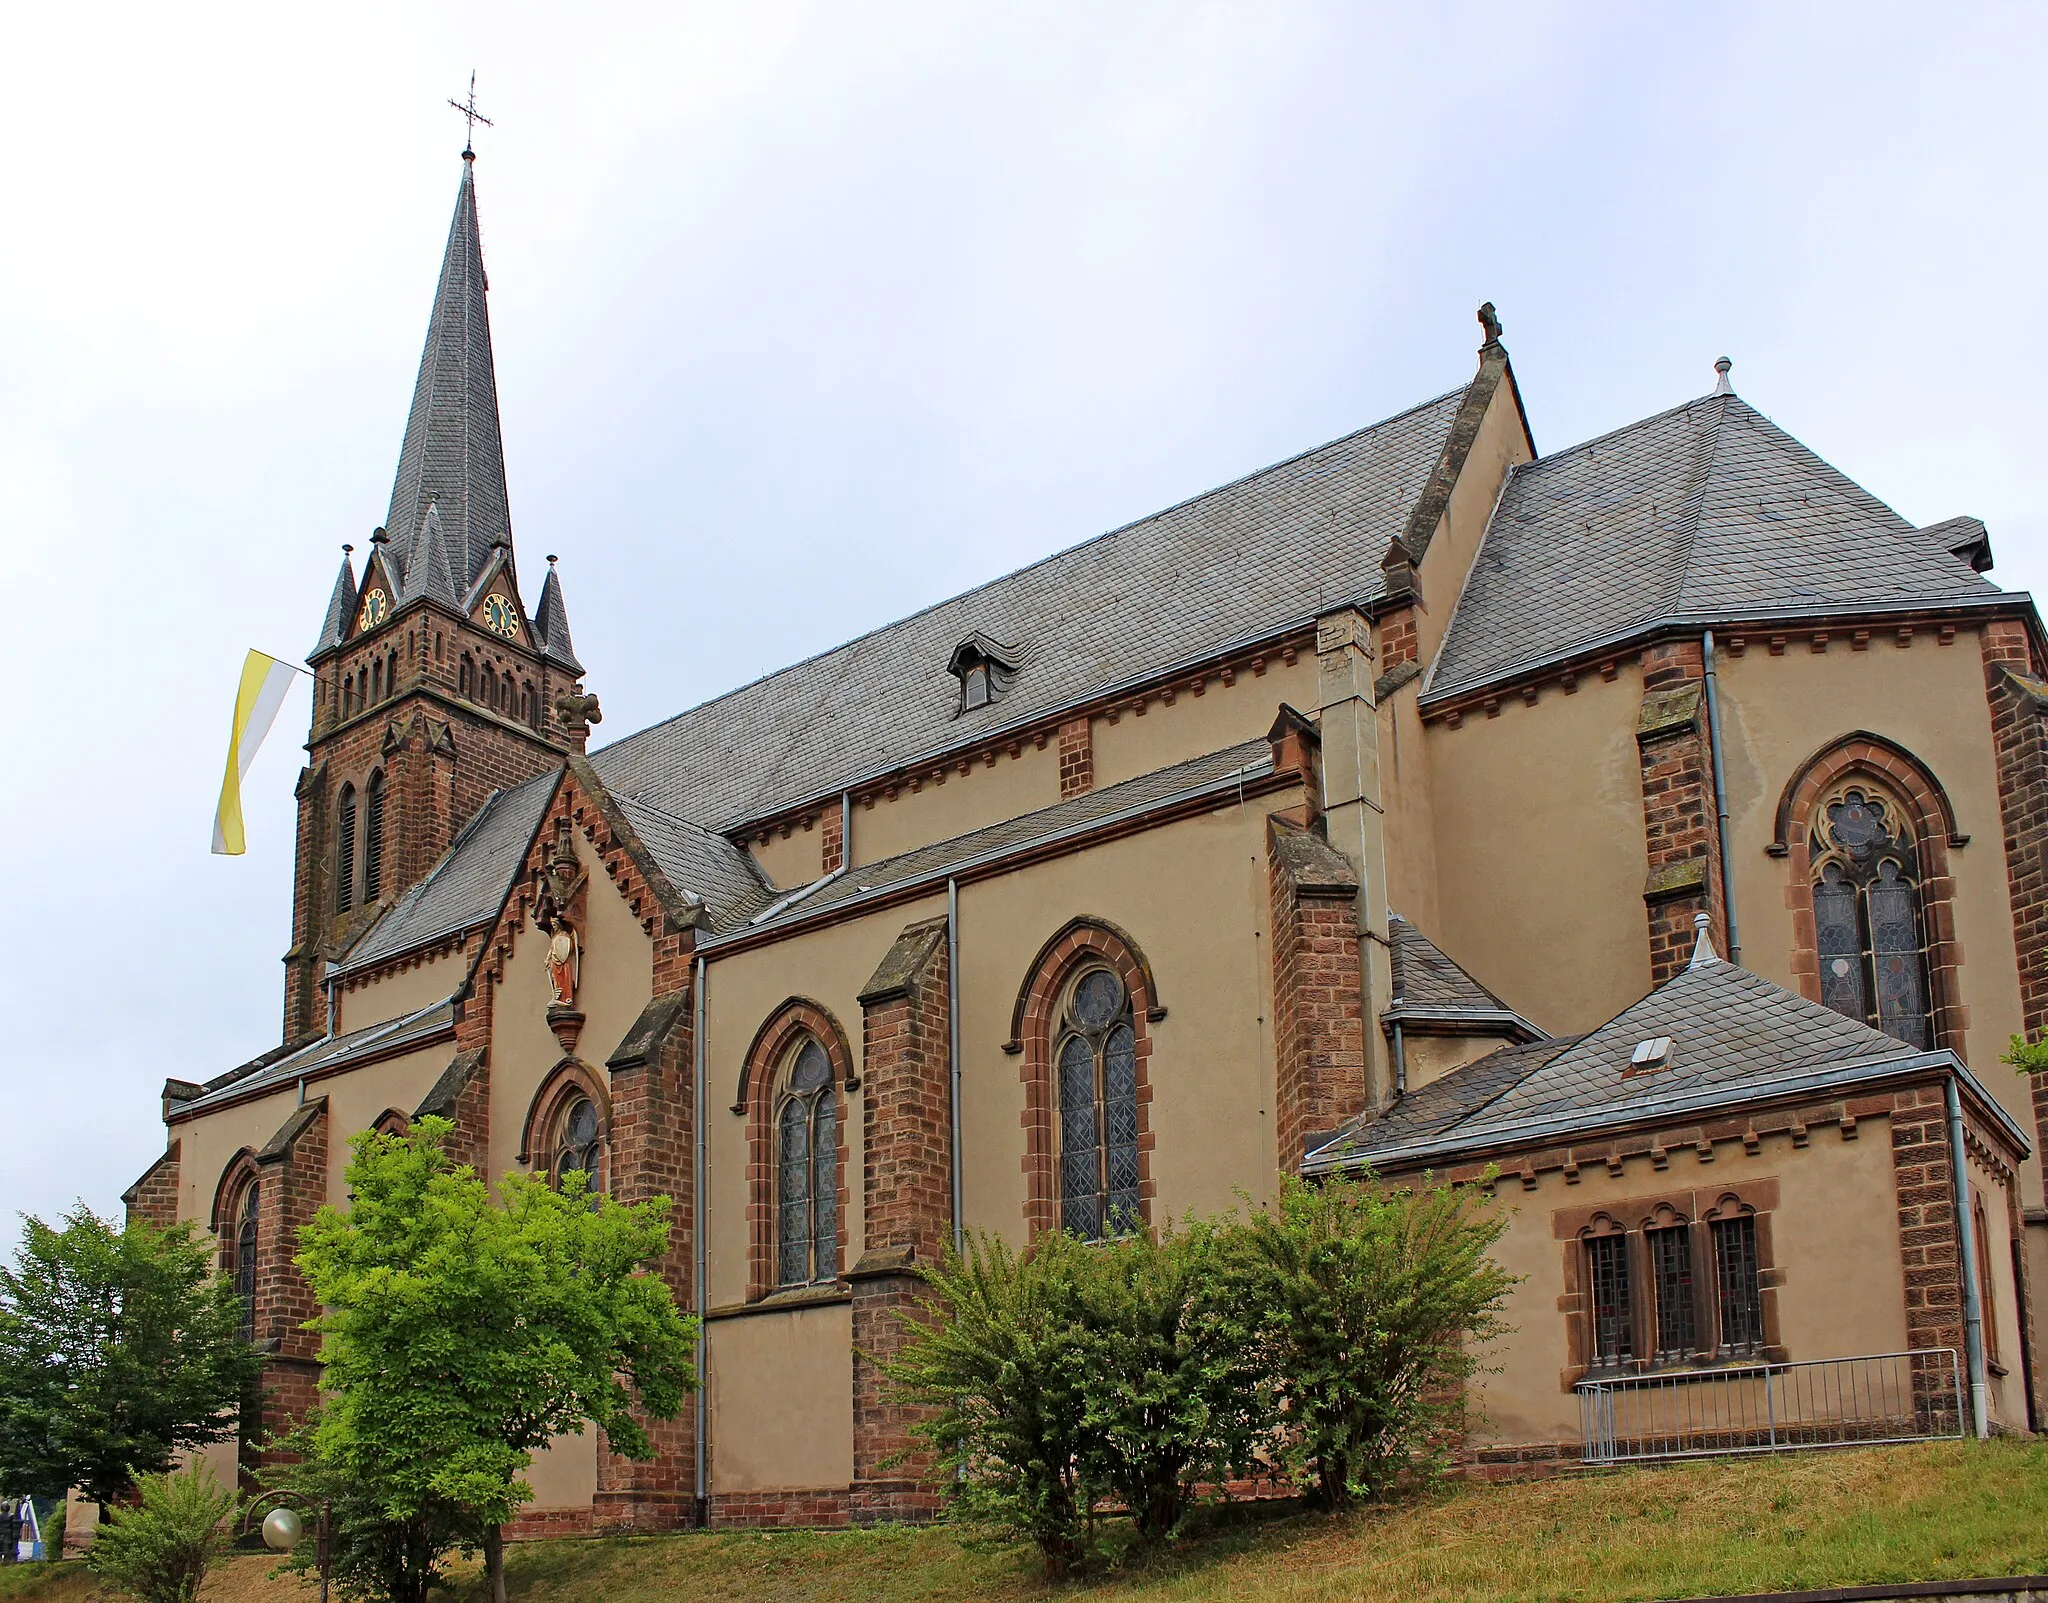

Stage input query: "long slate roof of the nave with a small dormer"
[{"left": 590, "top": 387, "right": 1464, "bottom": 829}]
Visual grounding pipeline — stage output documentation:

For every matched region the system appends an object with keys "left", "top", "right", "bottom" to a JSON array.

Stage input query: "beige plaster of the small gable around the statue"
[{"left": 489, "top": 829, "right": 653, "bottom": 1175}]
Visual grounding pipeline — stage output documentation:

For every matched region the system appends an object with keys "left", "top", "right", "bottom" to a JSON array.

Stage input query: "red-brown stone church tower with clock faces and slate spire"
[{"left": 285, "top": 149, "right": 596, "bottom": 1042}]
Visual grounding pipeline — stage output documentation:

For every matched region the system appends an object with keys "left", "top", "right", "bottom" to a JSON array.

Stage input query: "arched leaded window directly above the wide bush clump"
[{"left": 1053, "top": 968, "right": 1143, "bottom": 1241}]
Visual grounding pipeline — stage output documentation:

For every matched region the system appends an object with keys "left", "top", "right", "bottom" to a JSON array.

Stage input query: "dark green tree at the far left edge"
[{"left": 0, "top": 1204, "right": 260, "bottom": 1505}]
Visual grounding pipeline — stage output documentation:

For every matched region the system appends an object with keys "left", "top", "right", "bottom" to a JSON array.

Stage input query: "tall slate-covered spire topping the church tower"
[{"left": 385, "top": 151, "right": 510, "bottom": 594}]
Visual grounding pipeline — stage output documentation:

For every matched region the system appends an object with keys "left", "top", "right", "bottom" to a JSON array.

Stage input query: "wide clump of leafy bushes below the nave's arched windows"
[{"left": 881, "top": 1181, "right": 1513, "bottom": 1574}]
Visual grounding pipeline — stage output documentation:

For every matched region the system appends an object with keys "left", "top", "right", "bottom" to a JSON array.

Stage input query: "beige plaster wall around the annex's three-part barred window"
[{"left": 1475, "top": 1120, "right": 1907, "bottom": 1443}]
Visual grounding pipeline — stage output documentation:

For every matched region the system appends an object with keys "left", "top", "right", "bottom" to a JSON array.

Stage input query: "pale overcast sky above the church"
[{"left": 0, "top": 0, "right": 2048, "bottom": 1241}]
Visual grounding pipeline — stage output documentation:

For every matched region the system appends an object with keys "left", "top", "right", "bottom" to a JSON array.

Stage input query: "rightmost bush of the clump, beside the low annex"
[{"left": 1235, "top": 1177, "right": 1516, "bottom": 1509}]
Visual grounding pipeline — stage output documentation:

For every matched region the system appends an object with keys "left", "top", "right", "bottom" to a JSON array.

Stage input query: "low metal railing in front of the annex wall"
[{"left": 1577, "top": 1347, "right": 1970, "bottom": 1464}]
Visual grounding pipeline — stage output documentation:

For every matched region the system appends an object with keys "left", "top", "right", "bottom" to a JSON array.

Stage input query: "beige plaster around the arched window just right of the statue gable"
[{"left": 705, "top": 895, "right": 946, "bottom": 1308}]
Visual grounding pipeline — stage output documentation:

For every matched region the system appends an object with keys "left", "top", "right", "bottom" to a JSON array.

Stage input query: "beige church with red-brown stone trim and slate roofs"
[{"left": 127, "top": 154, "right": 2048, "bottom": 1535}]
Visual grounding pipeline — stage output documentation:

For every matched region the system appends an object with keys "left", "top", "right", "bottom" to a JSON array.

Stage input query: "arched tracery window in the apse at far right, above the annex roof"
[{"left": 1810, "top": 780, "right": 1933, "bottom": 1048}]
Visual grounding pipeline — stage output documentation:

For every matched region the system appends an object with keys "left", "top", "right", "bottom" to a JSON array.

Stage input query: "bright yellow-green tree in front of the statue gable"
[{"left": 297, "top": 1118, "right": 696, "bottom": 1597}]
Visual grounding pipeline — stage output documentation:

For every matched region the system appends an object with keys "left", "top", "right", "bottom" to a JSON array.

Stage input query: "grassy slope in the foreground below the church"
[{"left": 0, "top": 1441, "right": 2048, "bottom": 1603}]
